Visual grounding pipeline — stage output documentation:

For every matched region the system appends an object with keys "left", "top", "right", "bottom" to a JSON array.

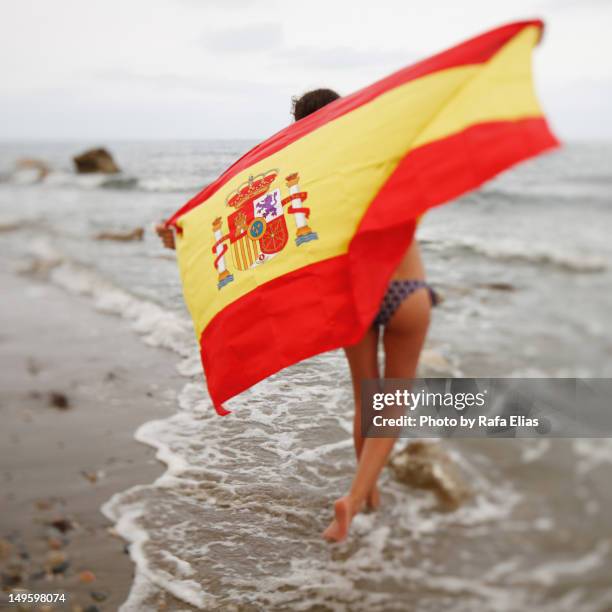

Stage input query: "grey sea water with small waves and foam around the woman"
[{"left": 0, "top": 141, "right": 612, "bottom": 611}]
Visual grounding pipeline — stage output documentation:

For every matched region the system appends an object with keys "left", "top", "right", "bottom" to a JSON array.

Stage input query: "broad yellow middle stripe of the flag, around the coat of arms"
[{"left": 177, "top": 26, "right": 542, "bottom": 339}]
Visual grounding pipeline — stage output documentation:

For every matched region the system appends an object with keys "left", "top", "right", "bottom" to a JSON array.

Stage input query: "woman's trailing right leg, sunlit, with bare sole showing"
[{"left": 323, "top": 243, "right": 431, "bottom": 541}]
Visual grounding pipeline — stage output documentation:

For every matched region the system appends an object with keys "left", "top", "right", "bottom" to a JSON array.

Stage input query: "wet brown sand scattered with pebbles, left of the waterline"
[{"left": 0, "top": 266, "right": 182, "bottom": 610}]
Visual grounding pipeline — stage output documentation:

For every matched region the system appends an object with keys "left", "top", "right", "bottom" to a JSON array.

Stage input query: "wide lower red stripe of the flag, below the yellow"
[{"left": 200, "top": 118, "right": 559, "bottom": 414}]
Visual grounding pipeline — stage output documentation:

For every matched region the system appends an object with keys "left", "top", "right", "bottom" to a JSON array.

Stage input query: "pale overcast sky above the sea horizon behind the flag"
[{"left": 0, "top": 0, "right": 612, "bottom": 142}]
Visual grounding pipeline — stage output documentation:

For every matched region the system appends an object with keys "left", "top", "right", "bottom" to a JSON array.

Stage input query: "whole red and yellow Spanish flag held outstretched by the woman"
[{"left": 167, "top": 21, "right": 558, "bottom": 414}]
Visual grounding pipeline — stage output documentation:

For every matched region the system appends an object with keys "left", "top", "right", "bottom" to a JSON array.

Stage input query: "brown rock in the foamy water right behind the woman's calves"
[{"left": 389, "top": 440, "right": 470, "bottom": 510}]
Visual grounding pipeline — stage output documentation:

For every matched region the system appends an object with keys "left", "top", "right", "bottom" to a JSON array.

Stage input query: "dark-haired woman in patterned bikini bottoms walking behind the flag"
[{"left": 156, "top": 89, "right": 434, "bottom": 542}]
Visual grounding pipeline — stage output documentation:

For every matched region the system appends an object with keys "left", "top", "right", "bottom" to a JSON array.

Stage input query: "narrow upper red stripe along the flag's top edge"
[{"left": 166, "top": 19, "right": 544, "bottom": 226}]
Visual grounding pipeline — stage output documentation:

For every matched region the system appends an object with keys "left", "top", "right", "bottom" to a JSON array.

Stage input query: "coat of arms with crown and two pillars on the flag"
[{"left": 212, "top": 170, "right": 318, "bottom": 289}]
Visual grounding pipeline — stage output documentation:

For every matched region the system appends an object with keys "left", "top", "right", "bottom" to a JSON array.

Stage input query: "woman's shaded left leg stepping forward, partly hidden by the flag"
[{"left": 344, "top": 327, "right": 380, "bottom": 508}]
